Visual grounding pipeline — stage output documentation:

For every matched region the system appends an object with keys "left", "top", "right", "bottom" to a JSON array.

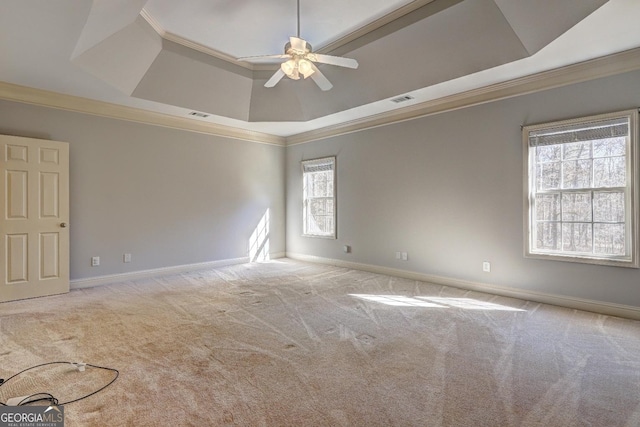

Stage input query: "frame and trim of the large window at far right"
[{"left": 522, "top": 109, "right": 640, "bottom": 268}]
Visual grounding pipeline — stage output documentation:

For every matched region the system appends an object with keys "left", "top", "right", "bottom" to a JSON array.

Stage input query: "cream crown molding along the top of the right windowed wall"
[{"left": 286, "top": 48, "right": 640, "bottom": 146}]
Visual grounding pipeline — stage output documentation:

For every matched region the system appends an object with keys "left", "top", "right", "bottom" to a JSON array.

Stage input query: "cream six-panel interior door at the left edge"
[{"left": 0, "top": 135, "right": 69, "bottom": 302}]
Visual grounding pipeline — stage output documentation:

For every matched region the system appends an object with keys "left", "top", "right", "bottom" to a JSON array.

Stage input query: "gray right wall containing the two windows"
[{"left": 286, "top": 72, "right": 640, "bottom": 306}]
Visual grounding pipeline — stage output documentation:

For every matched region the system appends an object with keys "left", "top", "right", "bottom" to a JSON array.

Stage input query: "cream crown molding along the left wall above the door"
[{"left": 0, "top": 82, "right": 286, "bottom": 146}]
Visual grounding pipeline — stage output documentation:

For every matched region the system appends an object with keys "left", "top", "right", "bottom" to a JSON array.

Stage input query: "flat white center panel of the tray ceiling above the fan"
[{"left": 144, "top": 0, "right": 424, "bottom": 58}]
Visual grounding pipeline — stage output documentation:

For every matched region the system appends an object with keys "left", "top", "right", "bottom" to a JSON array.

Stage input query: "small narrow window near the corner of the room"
[{"left": 302, "top": 157, "right": 336, "bottom": 239}]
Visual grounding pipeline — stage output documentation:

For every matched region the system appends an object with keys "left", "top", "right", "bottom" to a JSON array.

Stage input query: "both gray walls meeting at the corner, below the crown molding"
[{"left": 0, "top": 68, "right": 640, "bottom": 306}]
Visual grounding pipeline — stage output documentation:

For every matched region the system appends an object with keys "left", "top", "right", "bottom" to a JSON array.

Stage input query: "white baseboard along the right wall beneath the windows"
[{"left": 286, "top": 252, "right": 640, "bottom": 320}]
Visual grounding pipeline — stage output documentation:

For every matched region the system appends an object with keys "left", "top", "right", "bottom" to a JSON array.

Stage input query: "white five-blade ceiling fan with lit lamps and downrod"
[{"left": 238, "top": 0, "right": 358, "bottom": 91}]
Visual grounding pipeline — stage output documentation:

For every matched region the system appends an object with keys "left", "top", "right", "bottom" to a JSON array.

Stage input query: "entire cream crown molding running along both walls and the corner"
[{"left": 0, "top": 48, "right": 640, "bottom": 146}]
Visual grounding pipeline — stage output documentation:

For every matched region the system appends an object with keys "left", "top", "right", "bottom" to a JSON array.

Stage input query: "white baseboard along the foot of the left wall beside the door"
[{"left": 70, "top": 252, "right": 285, "bottom": 289}]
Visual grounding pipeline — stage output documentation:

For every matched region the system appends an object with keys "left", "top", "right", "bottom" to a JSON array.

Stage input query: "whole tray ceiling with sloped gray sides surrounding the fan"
[{"left": 0, "top": 0, "right": 640, "bottom": 136}]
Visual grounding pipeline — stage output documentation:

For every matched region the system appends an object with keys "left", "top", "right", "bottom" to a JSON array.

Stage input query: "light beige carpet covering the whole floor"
[{"left": 0, "top": 260, "right": 640, "bottom": 427}]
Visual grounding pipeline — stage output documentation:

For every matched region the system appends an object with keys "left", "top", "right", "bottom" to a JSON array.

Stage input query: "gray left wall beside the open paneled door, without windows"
[{"left": 0, "top": 101, "right": 285, "bottom": 280}]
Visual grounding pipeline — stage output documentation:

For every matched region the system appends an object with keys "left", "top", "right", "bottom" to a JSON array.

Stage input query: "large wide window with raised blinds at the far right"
[{"left": 523, "top": 110, "right": 639, "bottom": 268}]
